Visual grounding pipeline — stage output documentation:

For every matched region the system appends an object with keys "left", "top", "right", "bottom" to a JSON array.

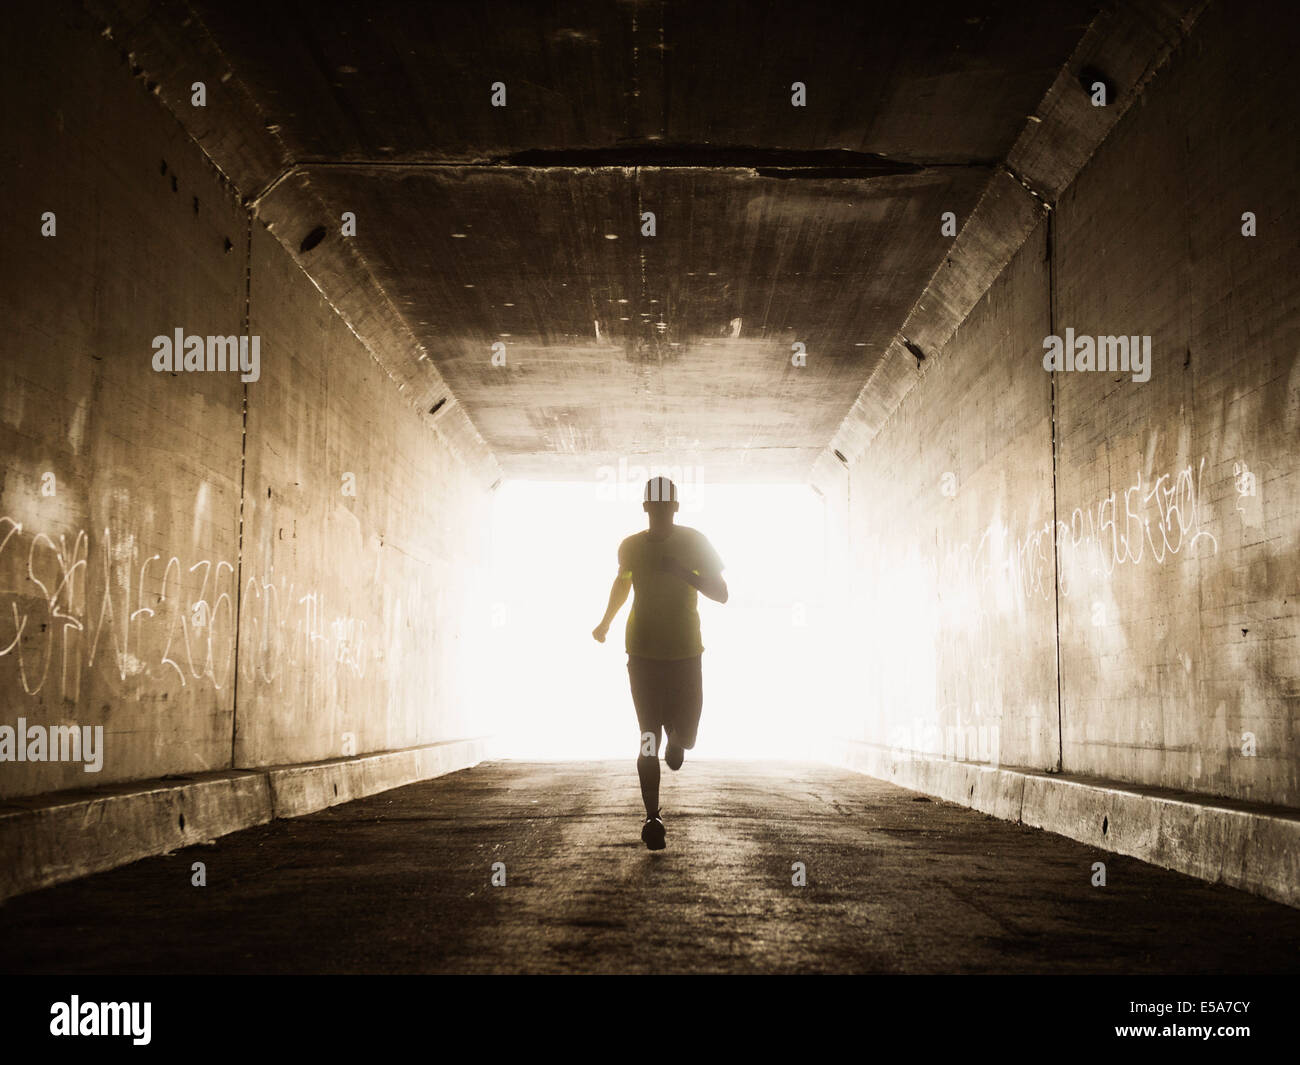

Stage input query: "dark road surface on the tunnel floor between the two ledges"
[{"left": 0, "top": 759, "right": 1300, "bottom": 974}]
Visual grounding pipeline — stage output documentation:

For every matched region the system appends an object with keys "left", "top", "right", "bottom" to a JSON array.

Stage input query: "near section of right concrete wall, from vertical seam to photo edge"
[{"left": 1056, "top": 3, "right": 1300, "bottom": 806}]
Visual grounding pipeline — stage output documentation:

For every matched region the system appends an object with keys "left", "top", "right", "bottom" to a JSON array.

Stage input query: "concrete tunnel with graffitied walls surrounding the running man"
[{"left": 0, "top": 0, "right": 1300, "bottom": 1009}]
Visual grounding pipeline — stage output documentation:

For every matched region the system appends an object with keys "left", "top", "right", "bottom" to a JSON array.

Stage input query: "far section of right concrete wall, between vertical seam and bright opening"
[{"left": 846, "top": 228, "right": 1058, "bottom": 767}]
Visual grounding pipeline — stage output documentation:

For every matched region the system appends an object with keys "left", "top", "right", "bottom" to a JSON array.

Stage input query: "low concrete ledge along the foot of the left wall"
[{"left": 0, "top": 736, "right": 489, "bottom": 901}]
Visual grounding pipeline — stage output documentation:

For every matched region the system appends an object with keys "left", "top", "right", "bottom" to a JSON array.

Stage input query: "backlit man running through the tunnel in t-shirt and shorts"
[{"left": 592, "top": 477, "right": 727, "bottom": 850}]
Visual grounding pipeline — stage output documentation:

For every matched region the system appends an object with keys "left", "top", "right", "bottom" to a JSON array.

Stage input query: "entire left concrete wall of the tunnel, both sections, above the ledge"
[{"left": 0, "top": 2, "right": 488, "bottom": 797}]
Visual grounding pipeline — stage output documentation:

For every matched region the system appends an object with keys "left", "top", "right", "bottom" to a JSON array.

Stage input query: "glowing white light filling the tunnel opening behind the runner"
[{"left": 478, "top": 481, "right": 848, "bottom": 761}]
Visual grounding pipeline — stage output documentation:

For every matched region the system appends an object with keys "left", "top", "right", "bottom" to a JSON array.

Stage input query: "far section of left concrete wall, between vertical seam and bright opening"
[{"left": 235, "top": 226, "right": 490, "bottom": 766}]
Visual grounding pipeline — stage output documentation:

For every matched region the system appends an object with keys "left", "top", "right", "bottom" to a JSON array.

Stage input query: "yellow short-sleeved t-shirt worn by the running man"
[{"left": 619, "top": 525, "right": 723, "bottom": 659}]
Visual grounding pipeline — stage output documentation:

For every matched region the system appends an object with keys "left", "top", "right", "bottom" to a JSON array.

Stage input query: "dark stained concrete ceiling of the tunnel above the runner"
[{"left": 129, "top": 0, "right": 1099, "bottom": 481}]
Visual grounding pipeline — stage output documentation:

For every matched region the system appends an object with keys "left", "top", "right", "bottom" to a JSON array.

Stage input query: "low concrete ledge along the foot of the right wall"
[{"left": 836, "top": 739, "right": 1300, "bottom": 906}]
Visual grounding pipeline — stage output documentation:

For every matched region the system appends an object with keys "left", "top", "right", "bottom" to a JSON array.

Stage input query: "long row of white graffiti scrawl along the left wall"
[{"left": 0, "top": 516, "right": 372, "bottom": 702}]
